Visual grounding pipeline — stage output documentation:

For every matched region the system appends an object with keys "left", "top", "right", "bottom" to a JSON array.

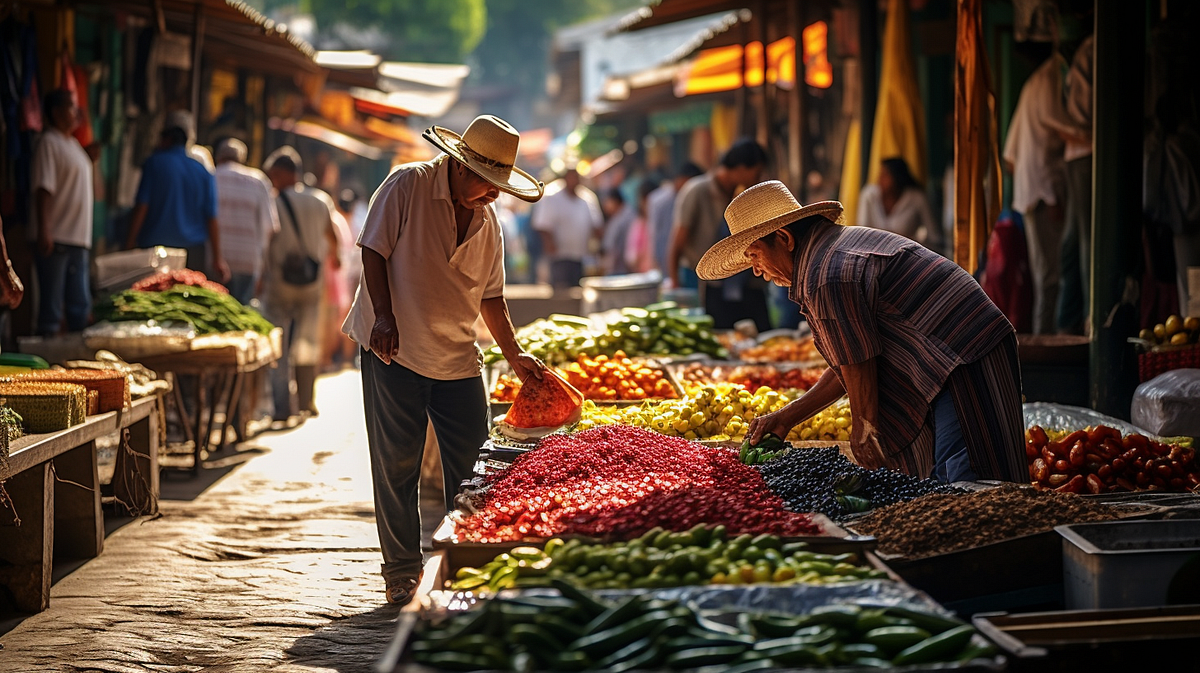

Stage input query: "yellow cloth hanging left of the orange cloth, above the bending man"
[{"left": 864, "top": 0, "right": 926, "bottom": 184}]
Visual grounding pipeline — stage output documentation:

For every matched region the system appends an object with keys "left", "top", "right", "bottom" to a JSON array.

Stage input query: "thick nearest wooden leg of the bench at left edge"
[{"left": 0, "top": 462, "right": 54, "bottom": 612}]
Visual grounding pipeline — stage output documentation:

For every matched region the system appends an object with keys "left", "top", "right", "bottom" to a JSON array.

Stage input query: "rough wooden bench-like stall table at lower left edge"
[{"left": 0, "top": 395, "right": 161, "bottom": 612}]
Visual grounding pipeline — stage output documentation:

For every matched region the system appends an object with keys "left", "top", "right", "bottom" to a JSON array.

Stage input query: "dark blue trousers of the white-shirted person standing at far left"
[{"left": 34, "top": 244, "right": 91, "bottom": 336}]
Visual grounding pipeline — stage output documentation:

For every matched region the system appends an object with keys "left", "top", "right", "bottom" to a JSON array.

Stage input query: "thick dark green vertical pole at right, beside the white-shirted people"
[{"left": 1091, "top": 0, "right": 1147, "bottom": 417}]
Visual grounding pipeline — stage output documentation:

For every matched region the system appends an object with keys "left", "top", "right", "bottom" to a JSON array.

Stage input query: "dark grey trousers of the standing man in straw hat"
[{"left": 361, "top": 350, "right": 487, "bottom": 583}]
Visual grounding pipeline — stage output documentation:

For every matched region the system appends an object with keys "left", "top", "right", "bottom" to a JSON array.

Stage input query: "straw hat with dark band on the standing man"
[{"left": 421, "top": 114, "right": 545, "bottom": 203}]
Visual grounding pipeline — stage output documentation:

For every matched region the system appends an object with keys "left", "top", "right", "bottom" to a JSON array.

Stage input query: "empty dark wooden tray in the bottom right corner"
[{"left": 972, "top": 605, "right": 1200, "bottom": 673}]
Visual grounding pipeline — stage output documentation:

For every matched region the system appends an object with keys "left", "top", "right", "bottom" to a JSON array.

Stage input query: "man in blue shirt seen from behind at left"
[{"left": 125, "top": 113, "right": 229, "bottom": 282}]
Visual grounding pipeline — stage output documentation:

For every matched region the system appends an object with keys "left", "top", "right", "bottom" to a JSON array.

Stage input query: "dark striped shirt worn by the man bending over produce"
[{"left": 788, "top": 223, "right": 1014, "bottom": 456}]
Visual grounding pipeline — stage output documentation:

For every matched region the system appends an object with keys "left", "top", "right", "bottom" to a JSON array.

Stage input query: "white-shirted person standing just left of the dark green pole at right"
[{"left": 1003, "top": 44, "right": 1074, "bottom": 335}]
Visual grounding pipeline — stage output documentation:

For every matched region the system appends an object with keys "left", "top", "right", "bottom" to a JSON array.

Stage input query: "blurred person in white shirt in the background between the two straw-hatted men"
[{"left": 533, "top": 168, "right": 604, "bottom": 288}]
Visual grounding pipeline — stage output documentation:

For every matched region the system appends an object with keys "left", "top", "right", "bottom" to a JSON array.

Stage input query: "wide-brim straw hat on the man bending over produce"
[{"left": 696, "top": 180, "right": 841, "bottom": 281}]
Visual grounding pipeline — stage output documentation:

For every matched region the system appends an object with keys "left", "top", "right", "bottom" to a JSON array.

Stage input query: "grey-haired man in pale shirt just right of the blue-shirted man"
[{"left": 215, "top": 138, "right": 280, "bottom": 304}]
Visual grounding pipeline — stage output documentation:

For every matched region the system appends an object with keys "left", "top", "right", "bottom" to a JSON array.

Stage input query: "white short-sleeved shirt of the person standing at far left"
[{"left": 30, "top": 127, "right": 92, "bottom": 248}]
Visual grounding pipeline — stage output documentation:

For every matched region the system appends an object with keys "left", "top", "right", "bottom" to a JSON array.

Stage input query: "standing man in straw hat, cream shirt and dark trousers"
[{"left": 342, "top": 115, "right": 545, "bottom": 605}]
